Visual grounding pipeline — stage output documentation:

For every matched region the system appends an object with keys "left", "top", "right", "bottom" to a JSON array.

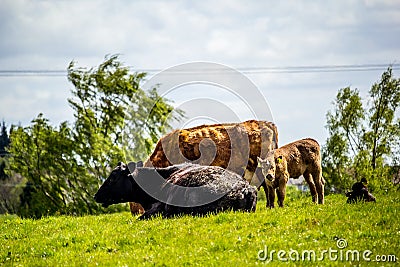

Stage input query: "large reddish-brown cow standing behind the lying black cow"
[{"left": 131, "top": 120, "right": 278, "bottom": 214}]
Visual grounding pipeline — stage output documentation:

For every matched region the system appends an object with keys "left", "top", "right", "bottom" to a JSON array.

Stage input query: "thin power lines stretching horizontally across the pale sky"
[{"left": 0, "top": 63, "right": 400, "bottom": 77}]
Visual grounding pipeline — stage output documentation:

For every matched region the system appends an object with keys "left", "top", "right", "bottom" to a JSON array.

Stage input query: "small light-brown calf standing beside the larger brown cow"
[{"left": 258, "top": 138, "right": 324, "bottom": 207}]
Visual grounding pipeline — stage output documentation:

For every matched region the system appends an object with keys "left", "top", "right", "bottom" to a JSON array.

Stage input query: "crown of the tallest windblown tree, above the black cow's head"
[{"left": 68, "top": 56, "right": 183, "bottom": 169}]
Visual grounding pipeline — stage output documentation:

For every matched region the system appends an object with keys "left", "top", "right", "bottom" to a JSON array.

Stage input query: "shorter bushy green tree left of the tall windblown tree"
[{"left": 9, "top": 114, "right": 71, "bottom": 217}]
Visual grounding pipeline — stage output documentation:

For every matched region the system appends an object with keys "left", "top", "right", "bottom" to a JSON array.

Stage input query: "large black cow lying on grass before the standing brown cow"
[{"left": 94, "top": 162, "right": 257, "bottom": 219}]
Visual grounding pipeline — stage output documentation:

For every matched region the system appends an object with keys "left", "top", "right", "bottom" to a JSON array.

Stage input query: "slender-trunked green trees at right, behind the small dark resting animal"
[{"left": 323, "top": 67, "right": 400, "bottom": 191}]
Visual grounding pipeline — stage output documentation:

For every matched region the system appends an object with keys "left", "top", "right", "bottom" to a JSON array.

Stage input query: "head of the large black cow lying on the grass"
[{"left": 94, "top": 162, "right": 142, "bottom": 207}]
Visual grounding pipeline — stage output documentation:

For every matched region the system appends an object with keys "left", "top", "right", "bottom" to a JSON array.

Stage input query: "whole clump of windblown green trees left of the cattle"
[{"left": 4, "top": 56, "right": 182, "bottom": 217}]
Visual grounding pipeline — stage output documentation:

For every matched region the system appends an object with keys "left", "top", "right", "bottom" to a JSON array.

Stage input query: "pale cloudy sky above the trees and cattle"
[{"left": 0, "top": 0, "right": 400, "bottom": 149}]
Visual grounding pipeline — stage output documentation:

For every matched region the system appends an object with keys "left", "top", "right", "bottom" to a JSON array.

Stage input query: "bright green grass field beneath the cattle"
[{"left": 0, "top": 189, "right": 400, "bottom": 267}]
